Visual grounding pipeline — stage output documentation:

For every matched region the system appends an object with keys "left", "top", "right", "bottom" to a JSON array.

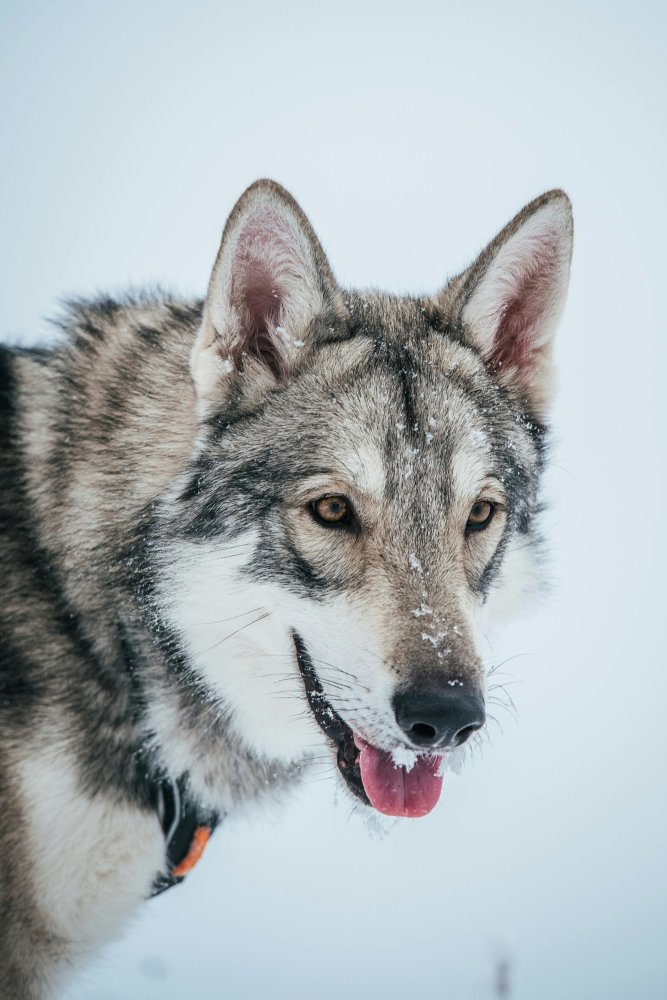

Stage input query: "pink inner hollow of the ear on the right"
[{"left": 491, "top": 240, "right": 558, "bottom": 370}]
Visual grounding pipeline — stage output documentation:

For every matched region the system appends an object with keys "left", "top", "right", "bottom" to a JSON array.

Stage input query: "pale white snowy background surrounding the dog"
[{"left": 0, "top": 0, "right": 667, "bottom": 1000}]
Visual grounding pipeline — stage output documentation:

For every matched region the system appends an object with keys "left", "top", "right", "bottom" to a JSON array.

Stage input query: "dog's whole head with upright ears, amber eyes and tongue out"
[{"left": 154, "top": 181, "right": 572, "bottom": 816}]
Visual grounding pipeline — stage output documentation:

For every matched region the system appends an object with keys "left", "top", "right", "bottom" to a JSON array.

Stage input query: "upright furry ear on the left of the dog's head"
[{"left": 190, "top": 180, "right": 344, "bottom": 416}]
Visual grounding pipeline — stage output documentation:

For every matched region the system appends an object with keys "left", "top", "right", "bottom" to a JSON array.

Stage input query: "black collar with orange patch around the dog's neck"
[{"left": 151, "top": 778, "right": 220, "bottom": 896}]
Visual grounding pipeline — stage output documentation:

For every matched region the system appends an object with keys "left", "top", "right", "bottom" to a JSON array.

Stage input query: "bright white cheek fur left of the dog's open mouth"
[{"left": 155, "top": 533, "right": 322, "bottom": 763}]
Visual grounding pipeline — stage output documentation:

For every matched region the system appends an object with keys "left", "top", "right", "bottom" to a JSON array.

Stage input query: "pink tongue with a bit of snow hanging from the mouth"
[{"left": 354, "top": 735, "right": 442, "bottom": 817}]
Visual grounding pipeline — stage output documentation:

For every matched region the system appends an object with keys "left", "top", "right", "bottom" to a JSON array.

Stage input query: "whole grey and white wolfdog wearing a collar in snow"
[{"left": 0, "top": 180, "right": 572, "bottom": 1000}]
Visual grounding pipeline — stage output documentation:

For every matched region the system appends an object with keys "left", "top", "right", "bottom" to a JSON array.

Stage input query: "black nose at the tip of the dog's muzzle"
[{"left": 394, "top": 686, "right": 484, "bottom": 747}]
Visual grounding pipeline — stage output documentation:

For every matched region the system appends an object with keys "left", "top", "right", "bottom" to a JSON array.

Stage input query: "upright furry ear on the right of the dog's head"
[{"left": 445, "top": 190, "right": 572, "bottom": 418}]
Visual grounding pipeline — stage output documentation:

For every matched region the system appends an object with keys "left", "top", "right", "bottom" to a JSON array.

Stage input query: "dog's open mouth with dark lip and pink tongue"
[{"left": 292, "top": 632, "right": 442, "bottom": 817}]
